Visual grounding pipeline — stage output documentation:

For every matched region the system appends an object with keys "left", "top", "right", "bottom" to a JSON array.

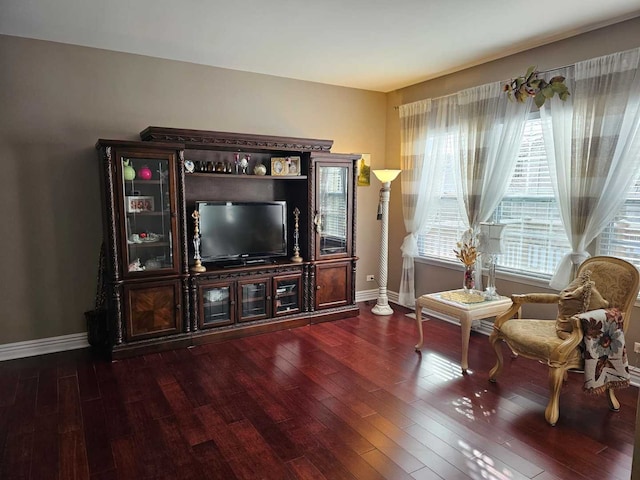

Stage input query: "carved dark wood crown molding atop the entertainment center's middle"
[{"left": 140, "top": 127, "right": 333, "bottom": 152}]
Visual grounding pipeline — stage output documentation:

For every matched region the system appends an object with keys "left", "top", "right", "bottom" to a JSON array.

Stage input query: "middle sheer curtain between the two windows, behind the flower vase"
[{"left": 457, "top": 82, "right": 532, "bottom": 290}]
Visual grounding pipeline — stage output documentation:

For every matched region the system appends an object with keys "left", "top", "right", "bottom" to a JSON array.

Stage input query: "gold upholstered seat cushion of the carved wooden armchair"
[{"left": 500, "top": 318, "right": 580, "bottom": 360}]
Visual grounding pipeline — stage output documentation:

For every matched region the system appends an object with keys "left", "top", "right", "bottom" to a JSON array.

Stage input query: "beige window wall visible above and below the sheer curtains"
[{"left": 386, "top": 18, "right": 640, "bottom": 366}]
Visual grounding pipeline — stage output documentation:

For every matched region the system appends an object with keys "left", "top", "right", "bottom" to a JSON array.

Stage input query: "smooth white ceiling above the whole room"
[{"left": 0, "top": 0, "right": 640, "bottom": 92}]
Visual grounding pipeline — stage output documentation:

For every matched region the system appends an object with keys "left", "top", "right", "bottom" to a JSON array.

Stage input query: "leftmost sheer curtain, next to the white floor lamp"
[{"left": 398, "top": 97, "right": 455, "bottom": 306}]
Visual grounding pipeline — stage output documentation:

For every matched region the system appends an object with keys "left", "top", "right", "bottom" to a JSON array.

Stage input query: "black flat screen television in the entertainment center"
[{"left": 196, "top": 201, "right": 287, "bottom": 263}]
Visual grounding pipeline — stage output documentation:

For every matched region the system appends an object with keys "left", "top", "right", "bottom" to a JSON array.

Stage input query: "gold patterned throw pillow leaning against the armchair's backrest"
[{"left": 556, "top": 270, "right": 609, "bottom": 340}]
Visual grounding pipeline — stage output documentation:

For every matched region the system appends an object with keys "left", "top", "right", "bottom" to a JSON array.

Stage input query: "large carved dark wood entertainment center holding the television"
[{"left": 96, "top": 127, "right": 360, "bottom": 358}]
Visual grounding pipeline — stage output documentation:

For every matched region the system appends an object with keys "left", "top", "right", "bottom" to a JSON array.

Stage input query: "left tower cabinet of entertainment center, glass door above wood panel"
[{"left": 97, "top": 140, "right": 187, "bottom": 349}]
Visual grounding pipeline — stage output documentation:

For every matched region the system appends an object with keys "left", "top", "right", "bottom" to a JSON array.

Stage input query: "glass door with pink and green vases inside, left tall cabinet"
[{"left": 118, "top": 154, "right": 179, "bottom": 276}]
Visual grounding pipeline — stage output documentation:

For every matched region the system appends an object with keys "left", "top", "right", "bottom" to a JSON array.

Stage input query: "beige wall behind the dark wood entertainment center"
[{"left": 0, "top": 36, "right": 386, "bottom": 344}]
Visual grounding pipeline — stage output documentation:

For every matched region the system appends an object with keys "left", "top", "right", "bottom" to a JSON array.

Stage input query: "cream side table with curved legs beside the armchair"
[{"left": 416, "top": 290, "right": 511, "bottom": 373}]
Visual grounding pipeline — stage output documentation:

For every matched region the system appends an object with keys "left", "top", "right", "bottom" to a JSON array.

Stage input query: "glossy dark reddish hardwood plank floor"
[{"left": 0, "top": 304, "right": 638, "bottom": 480}]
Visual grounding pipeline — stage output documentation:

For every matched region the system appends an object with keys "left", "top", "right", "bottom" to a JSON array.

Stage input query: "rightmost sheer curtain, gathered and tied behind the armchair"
[{"left": 540, "top": 48, "right": 640, "bottom": 290}]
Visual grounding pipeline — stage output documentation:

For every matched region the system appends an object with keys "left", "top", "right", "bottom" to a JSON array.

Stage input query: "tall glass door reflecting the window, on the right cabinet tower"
[{"left": 314, "top": 163, "right": 351, "bottom": 258}]
